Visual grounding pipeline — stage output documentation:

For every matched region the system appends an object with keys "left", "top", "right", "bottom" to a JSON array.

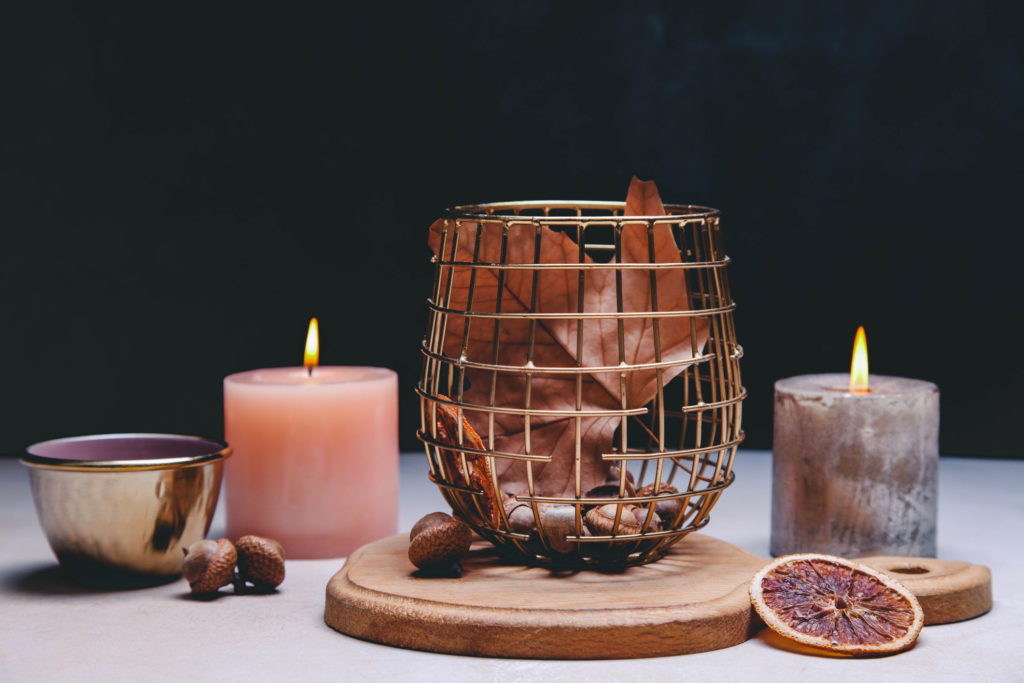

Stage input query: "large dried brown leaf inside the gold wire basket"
[{"left": 429, "top": 178, "right": 709, "bottom": 497}]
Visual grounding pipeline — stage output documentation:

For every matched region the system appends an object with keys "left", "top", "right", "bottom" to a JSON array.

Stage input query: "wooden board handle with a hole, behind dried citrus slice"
[{"left": 857, "top": 557, "right": 992, "bottom": 626}]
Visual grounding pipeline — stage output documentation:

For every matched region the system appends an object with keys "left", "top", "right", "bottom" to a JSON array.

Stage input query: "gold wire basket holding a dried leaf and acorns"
[{"left": 417, "top": 202, "right": 745, "bottom": 568}]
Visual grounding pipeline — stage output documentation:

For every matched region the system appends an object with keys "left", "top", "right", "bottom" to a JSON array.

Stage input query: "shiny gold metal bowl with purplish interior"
[{"left": 22, "top": 434, "right": 231, "bottom": 587}]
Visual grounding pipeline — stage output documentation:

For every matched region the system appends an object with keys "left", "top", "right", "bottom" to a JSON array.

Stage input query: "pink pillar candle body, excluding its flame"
[{"left": 224, "top": 367, "right": 398, "bottom": 559}]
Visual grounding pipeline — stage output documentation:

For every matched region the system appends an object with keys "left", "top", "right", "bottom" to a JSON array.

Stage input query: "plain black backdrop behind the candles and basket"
[{"left": 0, "top": 0, "right": 1024, "bottom": 456}]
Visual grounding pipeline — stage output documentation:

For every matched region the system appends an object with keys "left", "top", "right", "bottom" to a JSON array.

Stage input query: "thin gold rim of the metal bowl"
[{"left": 20, "top": 432, "right": 233, "bottom": 472}]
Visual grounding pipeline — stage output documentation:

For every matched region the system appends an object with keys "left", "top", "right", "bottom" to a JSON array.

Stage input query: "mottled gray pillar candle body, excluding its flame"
[{"left": 771, "top": 374, "right": 939, "bottom": 557}]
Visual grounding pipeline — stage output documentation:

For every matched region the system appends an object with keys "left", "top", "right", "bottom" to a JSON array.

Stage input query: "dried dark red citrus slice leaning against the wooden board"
[{"left": 751, "top": 554, "right": 925, "bottom": 654}]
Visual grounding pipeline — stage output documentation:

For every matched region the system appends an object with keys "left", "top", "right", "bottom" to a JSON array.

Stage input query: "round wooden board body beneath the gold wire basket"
[{"left": 324, "top": 533, "right": 765, "bottom": 659}]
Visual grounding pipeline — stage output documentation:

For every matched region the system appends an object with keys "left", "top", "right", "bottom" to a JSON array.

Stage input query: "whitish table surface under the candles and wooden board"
[{"left": 0, "top": 451, "right": 1024, "bottom": 683}]
